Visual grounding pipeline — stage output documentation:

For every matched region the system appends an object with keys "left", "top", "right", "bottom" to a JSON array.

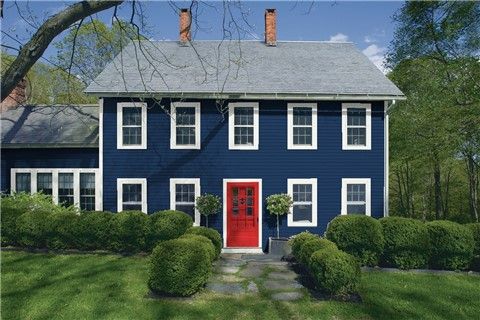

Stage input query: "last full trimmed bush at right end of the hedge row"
[{"left": 427, "top": 220, "right": 474, "bottom": 270}]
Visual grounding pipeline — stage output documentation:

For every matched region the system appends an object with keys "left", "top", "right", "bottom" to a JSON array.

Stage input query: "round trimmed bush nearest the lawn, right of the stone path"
[{"left": 309, "top": 248, "right": 360, "bottom": 295}]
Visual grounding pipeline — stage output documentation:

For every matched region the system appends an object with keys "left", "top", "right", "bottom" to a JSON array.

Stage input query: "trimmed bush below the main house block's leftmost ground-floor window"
[{"left": 110, "top": 211, "right": 148, "bottom": 253}]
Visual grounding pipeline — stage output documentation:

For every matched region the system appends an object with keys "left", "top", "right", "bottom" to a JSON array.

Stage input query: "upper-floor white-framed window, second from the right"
[{"left": 287, "top": 103, "right": 317, "bottom": 149}]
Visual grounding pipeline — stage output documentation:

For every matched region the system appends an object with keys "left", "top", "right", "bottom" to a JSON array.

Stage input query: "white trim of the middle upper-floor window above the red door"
[{"left": 228, "top": 102, "right": 260, "bottom": 150}]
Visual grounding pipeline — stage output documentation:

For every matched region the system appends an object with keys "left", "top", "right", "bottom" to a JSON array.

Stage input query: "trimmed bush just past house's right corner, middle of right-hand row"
[{"left": 380, "top": 217, "right": 430, "bottom": 269}]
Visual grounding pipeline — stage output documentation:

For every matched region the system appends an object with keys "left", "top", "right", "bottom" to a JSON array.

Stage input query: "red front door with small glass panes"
[{"left": 227, "top": 182, "right": 258, "bottom": 247}]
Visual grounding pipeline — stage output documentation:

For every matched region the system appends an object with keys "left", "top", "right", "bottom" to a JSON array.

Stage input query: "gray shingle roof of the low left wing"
[{"left": 0, "top": 105, "right": 98, "bottom": 148}]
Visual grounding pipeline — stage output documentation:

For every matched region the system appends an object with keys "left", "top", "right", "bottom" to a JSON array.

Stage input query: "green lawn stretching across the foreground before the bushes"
[{"left": 1, "top": 252, "right": 480, "bottom": 320}]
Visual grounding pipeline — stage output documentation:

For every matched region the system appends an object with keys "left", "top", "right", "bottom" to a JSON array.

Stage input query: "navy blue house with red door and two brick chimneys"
[{"left": 2, "top": 9, "right": 404, "bottom": 252}]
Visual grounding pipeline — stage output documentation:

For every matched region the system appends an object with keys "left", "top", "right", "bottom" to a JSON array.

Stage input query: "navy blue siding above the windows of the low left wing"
[{"left": 1, "top": 148, "right": 98, "bottom": 192}]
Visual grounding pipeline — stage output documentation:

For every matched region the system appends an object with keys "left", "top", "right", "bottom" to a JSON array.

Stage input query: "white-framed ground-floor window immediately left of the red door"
[{"left": 170, "top": 178, "right": 200, "bottom": 226}]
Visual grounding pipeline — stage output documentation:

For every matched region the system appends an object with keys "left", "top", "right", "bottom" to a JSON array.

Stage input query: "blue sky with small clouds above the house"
[{"left": 1, "top": 0, "right": 403, "bottom": 71}]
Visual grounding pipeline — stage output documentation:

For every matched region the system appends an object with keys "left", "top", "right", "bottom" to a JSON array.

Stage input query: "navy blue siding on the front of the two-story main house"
[{"left": 103, "top": 99, "right": 384, "bottom": 247}]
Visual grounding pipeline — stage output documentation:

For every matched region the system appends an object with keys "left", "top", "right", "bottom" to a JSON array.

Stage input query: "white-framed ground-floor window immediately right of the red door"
[{"left": 287, "top": 178, "right": 317, "bottom": 227}]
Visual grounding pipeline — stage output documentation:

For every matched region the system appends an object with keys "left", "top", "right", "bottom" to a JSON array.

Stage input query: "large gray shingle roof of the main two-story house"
[{"left": 86, "top": 41, "right": 403, "bottom": 97}]
